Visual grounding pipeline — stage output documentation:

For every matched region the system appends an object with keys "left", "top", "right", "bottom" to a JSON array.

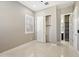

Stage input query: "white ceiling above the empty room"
[{"left": 20, "top": 1, "right": 74, "bottom": 11}]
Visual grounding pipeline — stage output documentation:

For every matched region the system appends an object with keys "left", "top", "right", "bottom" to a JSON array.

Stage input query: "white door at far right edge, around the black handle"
[{"left": 73, "top": 1, "right": 79, "bottom": 50}]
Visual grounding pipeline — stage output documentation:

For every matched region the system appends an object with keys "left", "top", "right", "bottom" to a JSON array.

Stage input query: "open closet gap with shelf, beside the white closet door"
[{"left": 46, "top": 15, "right": 51, "bottom": 42}]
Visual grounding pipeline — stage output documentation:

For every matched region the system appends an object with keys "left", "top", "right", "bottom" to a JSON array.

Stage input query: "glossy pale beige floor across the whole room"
[{"left": 0, "top": 40, "right": 79, "bottom": 57}]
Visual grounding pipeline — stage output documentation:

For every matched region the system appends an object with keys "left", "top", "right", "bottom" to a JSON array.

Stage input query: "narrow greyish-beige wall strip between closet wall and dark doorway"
[{"left": 56, "top": 7, "right": 61, "bottom": 43}]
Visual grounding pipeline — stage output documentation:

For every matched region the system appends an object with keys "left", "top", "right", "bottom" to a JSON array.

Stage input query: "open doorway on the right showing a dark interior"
[{"left": 61, "top": 14, "right": 70, "bottom": 42}]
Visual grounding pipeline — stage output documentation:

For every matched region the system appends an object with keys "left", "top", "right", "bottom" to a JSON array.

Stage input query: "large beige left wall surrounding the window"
[{"left": 0, "top": 1, "right": 34, "bottom": 52}]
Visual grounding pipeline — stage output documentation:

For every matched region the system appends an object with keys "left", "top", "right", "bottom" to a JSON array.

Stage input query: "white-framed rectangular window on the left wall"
[{"left": 25, "top": 15, "right": 34, "bottom": 34}]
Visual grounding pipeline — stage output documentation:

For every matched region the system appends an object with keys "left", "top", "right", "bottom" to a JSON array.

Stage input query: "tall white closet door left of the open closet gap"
[{"left": 36, "top": 16, "right": 46, "bottom": 42}]
